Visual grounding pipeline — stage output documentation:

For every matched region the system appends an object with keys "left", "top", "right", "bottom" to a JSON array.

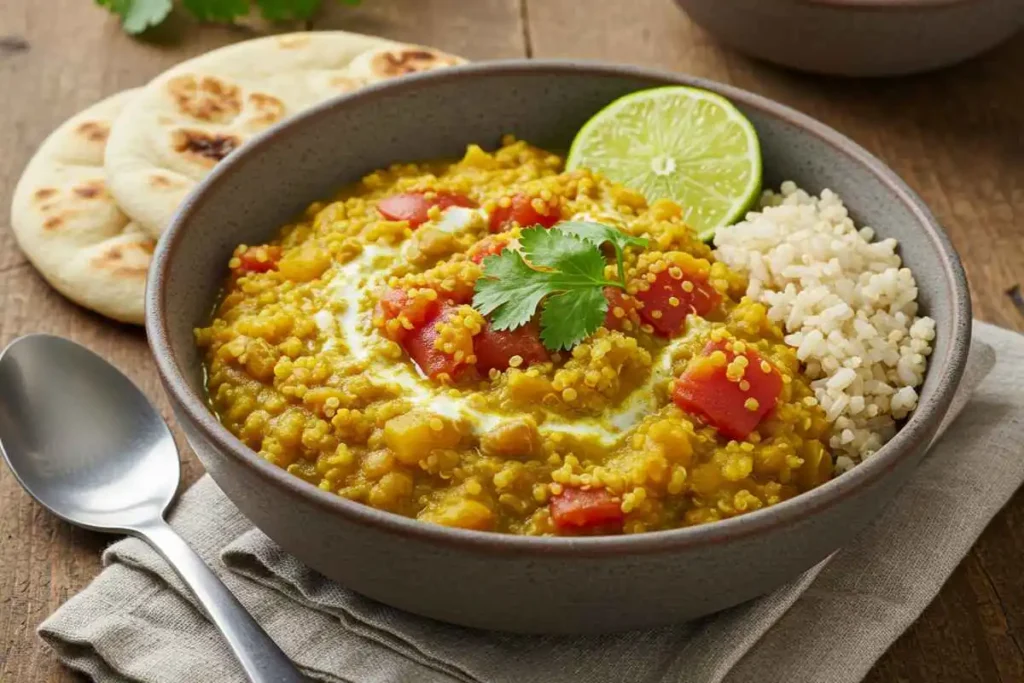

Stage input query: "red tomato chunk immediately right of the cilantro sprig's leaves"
[{"left": 636, "top": 267, "right": 722, "bottom": 337}]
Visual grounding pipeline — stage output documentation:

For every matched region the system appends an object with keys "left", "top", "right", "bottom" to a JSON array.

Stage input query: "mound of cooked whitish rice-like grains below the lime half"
[{"left": 715, "top": 182, "right": 935, "bottom": 471}]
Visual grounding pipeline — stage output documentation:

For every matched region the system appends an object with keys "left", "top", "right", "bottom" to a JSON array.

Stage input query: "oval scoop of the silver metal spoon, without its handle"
[{"left": 0, "top": 335, "right": 180, "bottom": 532}]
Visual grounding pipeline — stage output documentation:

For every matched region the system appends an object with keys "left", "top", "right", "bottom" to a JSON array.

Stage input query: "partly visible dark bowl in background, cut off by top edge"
[{"left": 676, "top": 0, "right": 1024, "bottom": 76}]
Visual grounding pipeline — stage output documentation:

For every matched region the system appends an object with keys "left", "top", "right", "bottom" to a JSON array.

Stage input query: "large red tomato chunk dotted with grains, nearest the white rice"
[{"left": 672, "top": 342, "right": 782, "bottom": 439}]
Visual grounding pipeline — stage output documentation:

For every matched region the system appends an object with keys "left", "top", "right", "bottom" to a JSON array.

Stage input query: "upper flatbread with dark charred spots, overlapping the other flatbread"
[{"left": 105, "top": 31, "right": 464, "bottom": 237}]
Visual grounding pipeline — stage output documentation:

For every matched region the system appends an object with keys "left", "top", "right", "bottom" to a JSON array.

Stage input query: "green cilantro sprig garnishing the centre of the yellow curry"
[{"left": 473, "top": 221, "right": 647, "bottom": 351}]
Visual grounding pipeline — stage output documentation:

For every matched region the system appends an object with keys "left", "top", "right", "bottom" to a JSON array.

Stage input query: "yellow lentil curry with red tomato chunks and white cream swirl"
[{"left": 196, "top": 138, "right": 833, "bottom": 536}]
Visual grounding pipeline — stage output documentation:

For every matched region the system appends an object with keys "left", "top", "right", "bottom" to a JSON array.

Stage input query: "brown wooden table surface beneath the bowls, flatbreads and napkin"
[{"left": 0, "top": 0, "right": 1024, "bottom": 683}]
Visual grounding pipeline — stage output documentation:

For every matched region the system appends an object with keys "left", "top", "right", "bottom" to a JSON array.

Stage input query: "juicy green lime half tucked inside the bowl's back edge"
[{"left": 566, "top": 86, "right": 761, "bottom": 240}]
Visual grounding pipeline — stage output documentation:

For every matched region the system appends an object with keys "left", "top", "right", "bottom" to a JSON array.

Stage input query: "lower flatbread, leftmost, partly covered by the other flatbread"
[{"left": 10, "top": 90, "right": 156, "bottom": 325}]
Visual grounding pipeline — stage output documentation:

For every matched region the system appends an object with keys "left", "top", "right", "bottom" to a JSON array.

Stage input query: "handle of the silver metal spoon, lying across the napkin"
[{"left": 134, "top": 518, "right": 306, "bottom": 683}]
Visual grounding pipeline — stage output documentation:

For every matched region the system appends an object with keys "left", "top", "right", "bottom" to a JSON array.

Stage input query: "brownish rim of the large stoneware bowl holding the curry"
[{"left": 145, "top": 59, "right": 971, "bottom": 557}]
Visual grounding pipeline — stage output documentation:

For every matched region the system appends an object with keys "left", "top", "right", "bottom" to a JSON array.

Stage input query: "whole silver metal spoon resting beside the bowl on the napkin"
[{"left": 0, "top": 335, "right": 305, "bottom": 683}]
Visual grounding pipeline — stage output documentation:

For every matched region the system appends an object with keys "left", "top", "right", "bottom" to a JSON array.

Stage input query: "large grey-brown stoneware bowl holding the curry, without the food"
[{"left": 146, "top": 61, "right": 971, "bottom": 633}]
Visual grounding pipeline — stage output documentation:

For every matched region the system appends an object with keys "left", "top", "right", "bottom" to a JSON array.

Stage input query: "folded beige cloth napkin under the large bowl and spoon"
[{"left": 39, "top": 323, "right": 1024, "bottom": 683}]
